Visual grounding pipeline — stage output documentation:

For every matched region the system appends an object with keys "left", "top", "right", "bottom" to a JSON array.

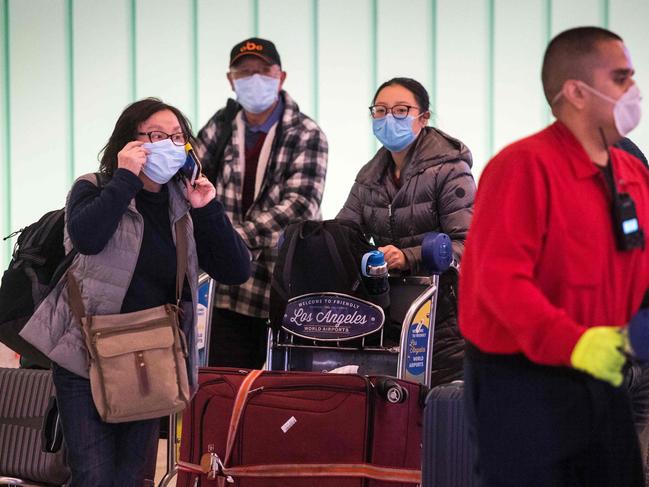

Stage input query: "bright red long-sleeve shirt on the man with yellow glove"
[{"left": 459, "top": 122, "right": 649, "bottom": 365}]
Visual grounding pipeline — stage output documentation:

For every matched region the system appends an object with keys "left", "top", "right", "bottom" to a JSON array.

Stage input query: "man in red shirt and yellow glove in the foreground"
[{"left": 459, "top": 27, "right": 649, "bottom": 487}]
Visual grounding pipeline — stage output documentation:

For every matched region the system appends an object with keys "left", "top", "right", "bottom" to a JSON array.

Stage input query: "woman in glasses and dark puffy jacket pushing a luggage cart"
[{"left": 336, "top": 78, "right": 475, "bottom": 385}]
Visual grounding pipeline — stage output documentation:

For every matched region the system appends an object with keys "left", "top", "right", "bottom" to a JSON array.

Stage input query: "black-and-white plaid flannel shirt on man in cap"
[{"left": 195, "top": 91, "right": 328, "bottom": 318}]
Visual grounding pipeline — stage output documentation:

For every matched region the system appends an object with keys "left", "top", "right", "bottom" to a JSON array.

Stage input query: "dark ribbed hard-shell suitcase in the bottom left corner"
[{"left": 0, "top": 368, "right": 70, "bottom": 486}]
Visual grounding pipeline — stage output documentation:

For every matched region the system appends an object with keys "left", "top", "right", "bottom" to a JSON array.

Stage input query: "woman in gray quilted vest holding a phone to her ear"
[{"left": 22, "top": 98, "right": 250, "bottom": 487}]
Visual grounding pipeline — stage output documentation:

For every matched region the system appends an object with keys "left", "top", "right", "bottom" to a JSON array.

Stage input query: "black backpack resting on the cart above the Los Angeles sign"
[{"left": 270, "top": 220, "right": 376, "bottom": 329}]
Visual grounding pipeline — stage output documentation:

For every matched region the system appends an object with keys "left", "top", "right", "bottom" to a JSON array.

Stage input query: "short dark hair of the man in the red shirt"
[{"left": 541, "top": 27, "right": 622, "bottom": 104}]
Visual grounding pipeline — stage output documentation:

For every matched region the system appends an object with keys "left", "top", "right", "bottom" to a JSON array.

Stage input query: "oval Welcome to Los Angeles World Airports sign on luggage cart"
[{"left": 282, "top": 293, "right": 385, "bottom": 341}]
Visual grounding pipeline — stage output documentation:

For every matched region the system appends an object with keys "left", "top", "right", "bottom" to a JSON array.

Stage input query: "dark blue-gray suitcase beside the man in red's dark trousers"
[{"left": 422, "top": 381, "right": 477, "bottom": 487}]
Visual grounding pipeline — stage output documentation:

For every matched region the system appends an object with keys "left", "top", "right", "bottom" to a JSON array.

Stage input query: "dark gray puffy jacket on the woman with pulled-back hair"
[{"left": 336, "top": 127, "right": 476, "bottom": 385}]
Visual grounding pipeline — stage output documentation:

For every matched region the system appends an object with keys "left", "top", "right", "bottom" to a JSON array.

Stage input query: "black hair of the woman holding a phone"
[{"left": 99, "top": 98, "right": 194, "bottom": 175}]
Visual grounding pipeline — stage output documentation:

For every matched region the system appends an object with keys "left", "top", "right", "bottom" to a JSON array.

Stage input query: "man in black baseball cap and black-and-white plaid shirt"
[{"left": 191, "top": 37, "right": 328, "bottom": 368}]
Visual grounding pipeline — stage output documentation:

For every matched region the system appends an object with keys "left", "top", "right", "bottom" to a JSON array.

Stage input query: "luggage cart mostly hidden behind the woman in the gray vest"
[{"left": 158, "top": 273, "right": 216, "bottom": 487}]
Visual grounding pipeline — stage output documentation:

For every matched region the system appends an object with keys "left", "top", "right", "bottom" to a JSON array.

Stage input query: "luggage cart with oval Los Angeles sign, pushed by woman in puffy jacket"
[{"left": 266, "top": 233, "right": 452, "bottom": 386}]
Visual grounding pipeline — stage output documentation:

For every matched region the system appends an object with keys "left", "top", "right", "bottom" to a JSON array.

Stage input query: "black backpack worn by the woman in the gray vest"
[{"left": 0, "top": 173, "right": 105, "bottom": 368}]
